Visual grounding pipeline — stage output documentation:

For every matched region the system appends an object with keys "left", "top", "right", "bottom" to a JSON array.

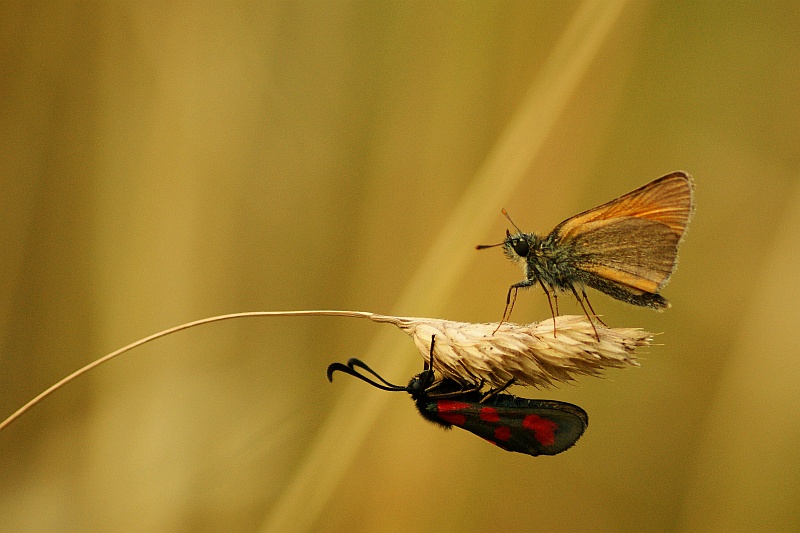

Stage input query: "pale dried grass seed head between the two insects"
[{"left": 370, "top": 315, "right": 652, "bottom": 387}]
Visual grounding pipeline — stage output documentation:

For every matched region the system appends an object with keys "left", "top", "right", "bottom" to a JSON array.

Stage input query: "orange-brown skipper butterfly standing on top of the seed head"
[{"left": 477, "top": 172, "right": 694, "bottom": 333}]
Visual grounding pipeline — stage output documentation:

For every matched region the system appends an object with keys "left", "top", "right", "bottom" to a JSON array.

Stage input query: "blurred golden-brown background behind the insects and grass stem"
[{"left": 0, "top": 1, "right": 800, "bottom": 532}]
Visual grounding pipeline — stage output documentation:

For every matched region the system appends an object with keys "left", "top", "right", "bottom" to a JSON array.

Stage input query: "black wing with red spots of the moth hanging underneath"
[{"left": 419, "top": 394, "right": 589, "bottom": 456}]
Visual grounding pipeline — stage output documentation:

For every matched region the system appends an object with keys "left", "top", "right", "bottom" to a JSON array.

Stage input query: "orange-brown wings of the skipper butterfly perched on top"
[{"left": 550, "top": 172, "right": 694, "bottom": 295}]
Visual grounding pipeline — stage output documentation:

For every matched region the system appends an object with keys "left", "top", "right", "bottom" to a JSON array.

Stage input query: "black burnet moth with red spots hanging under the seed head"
[{"left": 328, "top": 339, "right": 589, "bottom": 456}]
